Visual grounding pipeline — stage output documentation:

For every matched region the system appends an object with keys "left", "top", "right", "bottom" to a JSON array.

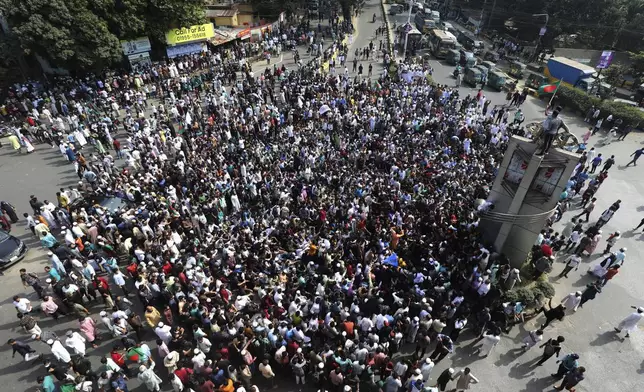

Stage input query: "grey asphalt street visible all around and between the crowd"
[{"left": 0, "top": 0, "right": 644, "bottom": 392}]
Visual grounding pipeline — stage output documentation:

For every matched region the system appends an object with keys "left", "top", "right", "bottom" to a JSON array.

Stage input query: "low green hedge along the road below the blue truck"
[{"left": 557, "top": 85, "right": 644, "bottom": 126}]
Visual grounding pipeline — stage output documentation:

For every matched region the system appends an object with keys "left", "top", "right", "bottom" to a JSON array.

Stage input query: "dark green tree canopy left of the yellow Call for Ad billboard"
[{"left": 0, "top": 0, "right": 204, "bottom": 71}]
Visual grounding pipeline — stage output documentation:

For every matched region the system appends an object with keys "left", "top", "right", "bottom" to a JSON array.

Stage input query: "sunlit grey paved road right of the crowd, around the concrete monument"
[{"left": 384, "top": 3, "right": 644, "bottom": 392}]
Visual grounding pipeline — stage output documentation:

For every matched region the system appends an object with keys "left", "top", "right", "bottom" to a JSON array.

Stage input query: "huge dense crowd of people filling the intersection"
[{"left": 3, "top": 6, "right": 641, "bottom": 392}]
